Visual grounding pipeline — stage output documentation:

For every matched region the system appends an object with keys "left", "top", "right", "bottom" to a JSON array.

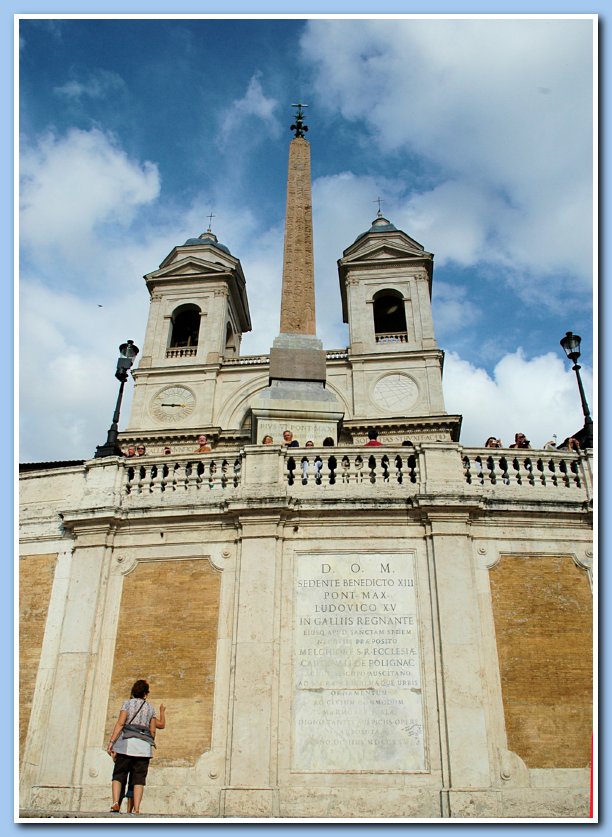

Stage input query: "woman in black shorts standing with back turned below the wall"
[{"left": 107, "top": 680, "right": 165, "bottom": 814}]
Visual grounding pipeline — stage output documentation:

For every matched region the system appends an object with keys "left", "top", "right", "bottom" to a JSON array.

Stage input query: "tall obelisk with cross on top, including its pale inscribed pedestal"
[{"left": 251, "top": 104, "right": 343, "bottom": 444}]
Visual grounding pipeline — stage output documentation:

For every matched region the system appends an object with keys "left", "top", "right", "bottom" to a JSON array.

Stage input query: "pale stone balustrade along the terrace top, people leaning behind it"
[{"left": 121, "top": 443, "right": 593, "bottom": 501}]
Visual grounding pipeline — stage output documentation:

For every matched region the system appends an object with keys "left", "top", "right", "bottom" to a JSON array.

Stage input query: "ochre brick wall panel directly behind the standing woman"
[{"left": 106, "top": 559, "right": 221, "bottom": 767}]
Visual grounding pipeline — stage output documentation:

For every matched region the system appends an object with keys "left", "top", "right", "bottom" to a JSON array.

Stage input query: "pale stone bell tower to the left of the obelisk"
[{"left": 124, "top": 227, "right": 251, "bottom": 439}]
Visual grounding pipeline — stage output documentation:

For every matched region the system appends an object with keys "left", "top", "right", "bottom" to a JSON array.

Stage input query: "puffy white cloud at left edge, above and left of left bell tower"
[{"left": 20, "top": 129, "right": 160, "bottom": 264}]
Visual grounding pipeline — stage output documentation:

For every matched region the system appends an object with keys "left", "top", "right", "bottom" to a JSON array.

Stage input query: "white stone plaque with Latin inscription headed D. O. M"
[{"left": 292, "top": 553, "right": 427, "bottom": 772}]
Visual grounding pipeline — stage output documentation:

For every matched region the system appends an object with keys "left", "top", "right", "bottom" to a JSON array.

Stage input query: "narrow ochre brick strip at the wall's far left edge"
[{"left": 19, "top": 553, "right": 57, "bottom": 754}]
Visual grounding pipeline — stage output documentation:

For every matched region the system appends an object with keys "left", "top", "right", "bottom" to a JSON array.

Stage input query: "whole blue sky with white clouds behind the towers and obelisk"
[{"left": 17, "top": 16, "right": 597, "bottom": 462}]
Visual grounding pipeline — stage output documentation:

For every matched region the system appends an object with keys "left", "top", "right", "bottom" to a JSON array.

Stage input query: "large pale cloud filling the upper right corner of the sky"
[{"left": 302, "top": 19, "right": 593, "bottom": 296}]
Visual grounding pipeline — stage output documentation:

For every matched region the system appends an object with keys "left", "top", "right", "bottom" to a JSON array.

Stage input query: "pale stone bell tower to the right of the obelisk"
[{"left": 338, "top": 210, "right": 461, "bottom": 441}]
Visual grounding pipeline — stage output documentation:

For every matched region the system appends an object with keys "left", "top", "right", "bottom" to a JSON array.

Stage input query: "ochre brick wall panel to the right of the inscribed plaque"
[{"left": 490, "top": 556, "right": 593, "bottom": 768}]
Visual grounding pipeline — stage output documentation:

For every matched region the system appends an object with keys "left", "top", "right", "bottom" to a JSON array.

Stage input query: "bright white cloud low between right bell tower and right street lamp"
[{"left": 444, "top": 349, "right": 592, "bottom": 447}]
